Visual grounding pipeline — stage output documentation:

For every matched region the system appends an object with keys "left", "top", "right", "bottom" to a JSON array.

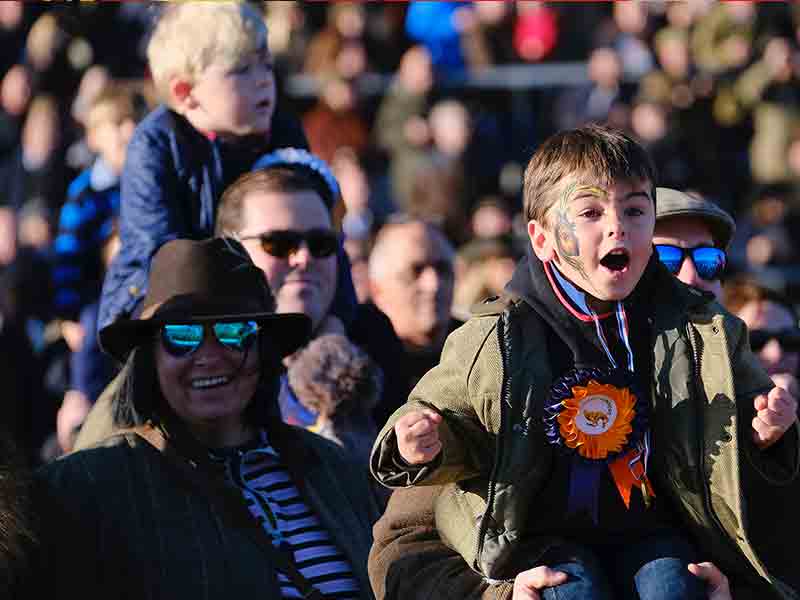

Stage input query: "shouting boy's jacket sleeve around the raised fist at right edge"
[{"left": 728, "top": 319, "right": 800, "bottom": 485}]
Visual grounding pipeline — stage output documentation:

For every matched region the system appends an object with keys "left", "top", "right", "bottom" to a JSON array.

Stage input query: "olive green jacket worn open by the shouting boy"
[{"left": 371, "top": 277, "right": 800, "bottom": 598}]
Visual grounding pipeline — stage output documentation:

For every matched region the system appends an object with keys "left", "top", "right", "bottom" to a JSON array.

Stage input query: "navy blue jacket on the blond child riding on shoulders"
[{"left": 98, "top": 106, "right": 310, "bottom": 329}]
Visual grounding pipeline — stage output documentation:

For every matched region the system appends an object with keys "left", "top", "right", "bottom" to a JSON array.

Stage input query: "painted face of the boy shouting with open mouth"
[{"left": 547, "top": 181, "right": 655, "bottom": 300}]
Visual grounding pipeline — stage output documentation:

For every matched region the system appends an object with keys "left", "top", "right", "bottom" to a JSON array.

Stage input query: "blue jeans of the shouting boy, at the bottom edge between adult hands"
[{"left": 541, "top": 535, "right": 707, "bottom": 600}]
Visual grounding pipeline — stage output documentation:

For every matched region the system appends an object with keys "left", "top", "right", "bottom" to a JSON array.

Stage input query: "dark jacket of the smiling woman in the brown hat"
[{"left": 31, "top": 425, "right": 379, "bottom": 600}]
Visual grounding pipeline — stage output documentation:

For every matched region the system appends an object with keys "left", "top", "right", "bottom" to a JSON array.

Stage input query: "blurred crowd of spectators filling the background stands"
[{"left": 0, "top": 0, "right": 800, "bottom": 463}]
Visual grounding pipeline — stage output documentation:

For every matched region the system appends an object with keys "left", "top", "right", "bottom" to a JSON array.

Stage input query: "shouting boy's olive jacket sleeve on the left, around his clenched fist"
[{"left": 370, "top": 317, "right": 502, "bottom": 487}]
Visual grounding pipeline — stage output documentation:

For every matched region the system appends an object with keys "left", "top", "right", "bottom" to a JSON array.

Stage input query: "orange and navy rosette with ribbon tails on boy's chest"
[{"left": 544, "top": 367, "right": 655, "bottom": 523}]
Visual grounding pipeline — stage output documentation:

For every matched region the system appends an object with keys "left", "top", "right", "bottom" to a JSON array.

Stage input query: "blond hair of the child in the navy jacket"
[{"left": 147, "top": 2, "right": 267, "bottom": 103}]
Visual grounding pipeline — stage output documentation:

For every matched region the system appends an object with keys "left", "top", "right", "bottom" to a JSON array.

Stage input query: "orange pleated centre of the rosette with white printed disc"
[{"left": 557, "top": 379, "right": 636, "bottom": 459}]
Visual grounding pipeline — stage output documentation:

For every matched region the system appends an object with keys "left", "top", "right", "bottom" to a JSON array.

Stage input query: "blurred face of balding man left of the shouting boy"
[{"left": 370, "top": 225, "right": 453, "bottom": 348}]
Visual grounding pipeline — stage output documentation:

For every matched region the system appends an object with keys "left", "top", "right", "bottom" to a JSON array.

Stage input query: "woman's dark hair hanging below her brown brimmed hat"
[{"left": 111, "top": 335, "right": 282, "bottom": 428}]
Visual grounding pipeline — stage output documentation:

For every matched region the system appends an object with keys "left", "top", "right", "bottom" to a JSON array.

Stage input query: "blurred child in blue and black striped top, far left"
[{"left": 52, "top": 87, "right": 136, "bottom": 451}]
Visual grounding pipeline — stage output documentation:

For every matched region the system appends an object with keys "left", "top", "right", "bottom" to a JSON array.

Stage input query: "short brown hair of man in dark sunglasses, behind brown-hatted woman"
[{"left": 214, "top": 167, "right": 325, "bottom": 237}]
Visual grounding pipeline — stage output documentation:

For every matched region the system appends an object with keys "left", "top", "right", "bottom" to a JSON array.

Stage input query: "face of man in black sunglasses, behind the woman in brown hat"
[{"left": 239, "top": 191, "right": 337, "bottom": 329}]
